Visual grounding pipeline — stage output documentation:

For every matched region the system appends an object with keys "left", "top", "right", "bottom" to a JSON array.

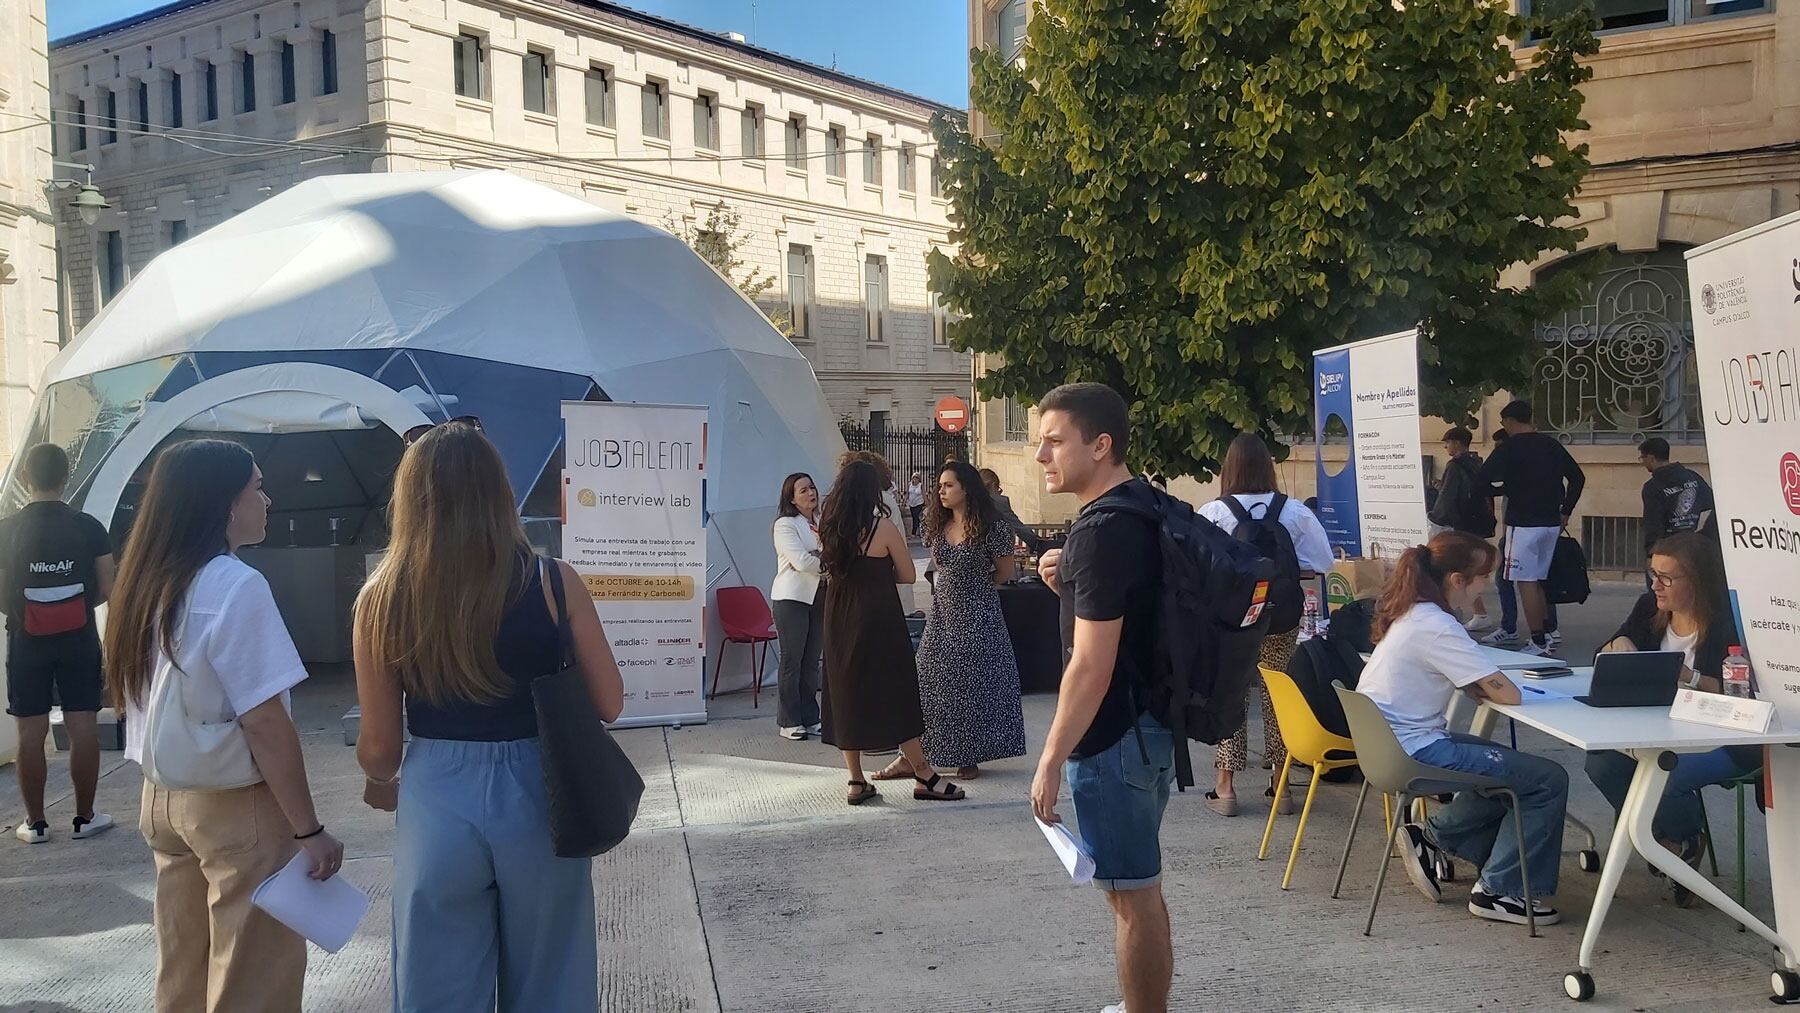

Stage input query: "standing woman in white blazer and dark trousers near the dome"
[{"left": 769, "top": 471, "right": 824, "bottom": 741}]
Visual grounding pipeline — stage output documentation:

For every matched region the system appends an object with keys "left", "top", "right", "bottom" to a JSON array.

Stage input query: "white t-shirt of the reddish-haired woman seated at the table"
[{"left": 1355, "top": 601, "right": 1496, "bottom": 756}]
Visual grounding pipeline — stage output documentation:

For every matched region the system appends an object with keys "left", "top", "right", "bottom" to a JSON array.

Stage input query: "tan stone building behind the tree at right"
[{"left": 970, "top": 0, "right": 1800, "bottom": 570}]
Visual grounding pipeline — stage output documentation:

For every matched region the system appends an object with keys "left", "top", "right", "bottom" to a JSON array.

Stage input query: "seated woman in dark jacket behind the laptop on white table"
[{"left": 1588, "top": 533, "right": 1762, "bottom": 907}]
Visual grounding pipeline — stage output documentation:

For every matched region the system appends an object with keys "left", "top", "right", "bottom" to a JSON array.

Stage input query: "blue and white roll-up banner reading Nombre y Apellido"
[{"left": 1312, "top": 329, "right": 1431, "bottom": 560}]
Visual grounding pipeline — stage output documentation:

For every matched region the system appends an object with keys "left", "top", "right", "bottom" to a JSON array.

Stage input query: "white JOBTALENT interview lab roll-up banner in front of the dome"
[{"left": 562, "top": 401, "right": 706, "bottom": 727}]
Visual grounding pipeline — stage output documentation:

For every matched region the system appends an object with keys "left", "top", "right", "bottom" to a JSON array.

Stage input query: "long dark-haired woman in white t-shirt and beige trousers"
[{"left": 106, "top": 439, "right": 344, "bottom": 1013}]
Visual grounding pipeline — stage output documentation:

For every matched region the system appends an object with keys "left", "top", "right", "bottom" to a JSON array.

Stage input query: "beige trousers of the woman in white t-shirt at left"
[{"left": 139, "top": 781, "right": 306, "bottom": 1013}]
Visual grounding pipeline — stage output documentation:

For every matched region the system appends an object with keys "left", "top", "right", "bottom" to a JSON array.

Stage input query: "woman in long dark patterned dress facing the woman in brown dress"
[{"left": 875, "top": 461, "right": 1024, "bottom": 781}]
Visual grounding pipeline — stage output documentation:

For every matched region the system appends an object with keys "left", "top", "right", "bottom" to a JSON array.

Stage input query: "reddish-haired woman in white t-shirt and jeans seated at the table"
[{"left": 1357, "top": 531, "right": 1570, "bottom": 925}]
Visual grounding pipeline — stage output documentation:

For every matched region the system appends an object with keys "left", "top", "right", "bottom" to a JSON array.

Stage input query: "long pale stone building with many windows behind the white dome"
[{"left": 50, "top": 0, "right": 970, "bottom": 426}]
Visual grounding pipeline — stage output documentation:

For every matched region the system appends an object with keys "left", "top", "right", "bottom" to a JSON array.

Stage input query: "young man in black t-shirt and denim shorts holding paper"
[{"left": 1031, "top": 383, "right": 1175, "bottom": 1013}]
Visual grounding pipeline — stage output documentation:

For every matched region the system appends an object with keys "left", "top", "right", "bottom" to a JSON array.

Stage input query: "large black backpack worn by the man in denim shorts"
[{"left": 1102, "top": 480, "right": 1274, "bottom": 790}]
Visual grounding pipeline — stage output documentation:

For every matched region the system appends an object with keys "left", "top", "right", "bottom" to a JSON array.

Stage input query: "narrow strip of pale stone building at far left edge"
[{"left": 0, "top": 0, "right": 61, "bottom": 466}]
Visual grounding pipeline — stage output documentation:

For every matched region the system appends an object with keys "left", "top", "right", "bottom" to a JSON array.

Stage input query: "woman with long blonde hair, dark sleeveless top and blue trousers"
[{"left": 355, "top": 419, "right": 625, "bottom": 1013}]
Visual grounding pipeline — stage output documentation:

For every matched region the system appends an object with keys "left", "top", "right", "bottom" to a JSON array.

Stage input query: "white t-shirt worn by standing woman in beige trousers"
[{"left": 124, "top": 556, "right": 306, "bottom": 763}]
